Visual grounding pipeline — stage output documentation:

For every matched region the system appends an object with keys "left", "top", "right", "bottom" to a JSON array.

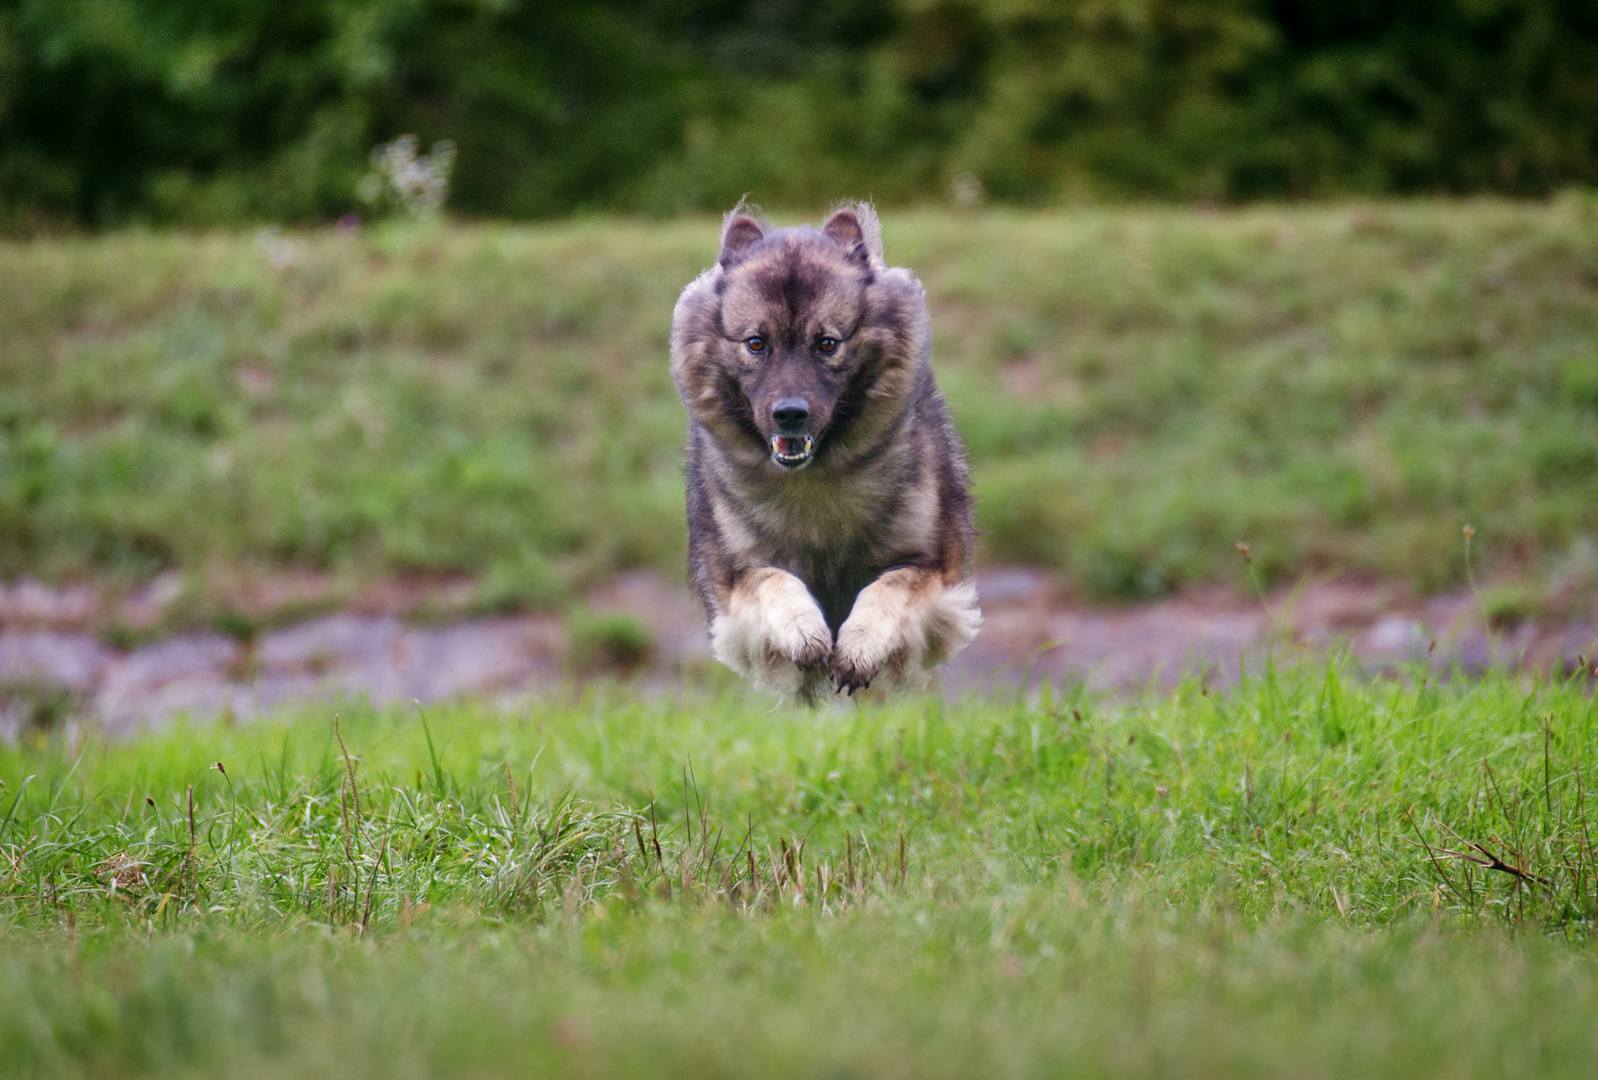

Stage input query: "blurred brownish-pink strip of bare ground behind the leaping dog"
[{"left": 0, "top": 567, "right": 1598, "bottom": 737}]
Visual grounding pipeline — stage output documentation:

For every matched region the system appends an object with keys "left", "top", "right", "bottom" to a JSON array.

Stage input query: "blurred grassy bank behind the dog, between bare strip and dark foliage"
[{"left": 0, "top": 195, "right": 1598, "bottom": 617}]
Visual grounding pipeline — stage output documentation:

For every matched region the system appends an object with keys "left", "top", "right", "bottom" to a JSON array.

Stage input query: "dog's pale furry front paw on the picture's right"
[{"left": 833, "top": 567, "right": 983, "bottom": 693}]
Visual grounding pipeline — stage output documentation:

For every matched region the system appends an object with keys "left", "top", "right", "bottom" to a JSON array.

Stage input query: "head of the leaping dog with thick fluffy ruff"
[{"left": 671, "top": 206, "right": 928, "bottom": 470}]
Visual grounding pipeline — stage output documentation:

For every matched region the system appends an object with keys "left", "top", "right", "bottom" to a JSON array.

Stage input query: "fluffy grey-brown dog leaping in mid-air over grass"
[{"left": 671, "top": 204, "right": 981, "bottom": 705}]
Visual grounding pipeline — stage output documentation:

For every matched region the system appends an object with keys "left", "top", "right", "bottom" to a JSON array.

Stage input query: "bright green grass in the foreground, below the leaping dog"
[{"left": 0, "top": 668, "right": 1598, "bottom": 1077}]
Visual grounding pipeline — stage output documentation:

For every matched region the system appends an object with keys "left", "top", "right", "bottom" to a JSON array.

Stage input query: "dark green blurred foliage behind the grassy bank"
[{"left": 0, "top": 0, "right": 1598, "bottom": 230}]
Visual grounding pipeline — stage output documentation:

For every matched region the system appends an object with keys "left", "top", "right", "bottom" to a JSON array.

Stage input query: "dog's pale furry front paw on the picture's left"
[{"left": 710, "top": 567, "right": 833, "bottom": 701}]
